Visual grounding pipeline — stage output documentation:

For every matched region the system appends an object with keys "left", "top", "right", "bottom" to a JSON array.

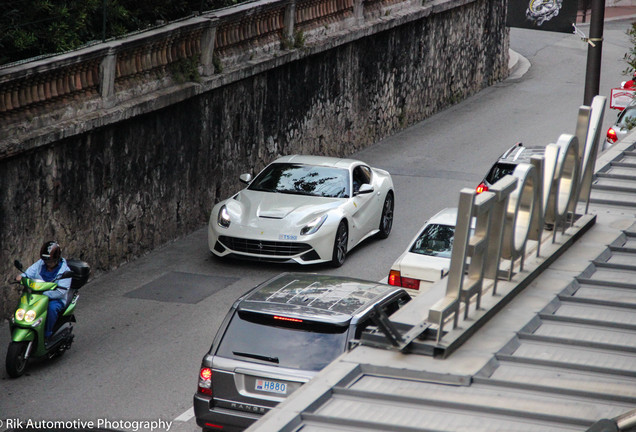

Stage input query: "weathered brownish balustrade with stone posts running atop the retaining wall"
[{"left": 0, "top": 0, "right": 398, "bottom": 133}]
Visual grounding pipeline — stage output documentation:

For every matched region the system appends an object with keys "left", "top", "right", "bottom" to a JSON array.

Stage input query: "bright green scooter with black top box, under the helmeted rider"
[{"left": 6, "top": 260, "right": 90, "bottom": 378}]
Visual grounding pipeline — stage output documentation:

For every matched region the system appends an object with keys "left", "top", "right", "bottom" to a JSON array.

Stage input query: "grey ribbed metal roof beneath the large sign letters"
[{"left": 249, "top": 138, "right": 636, "bottom": 432}]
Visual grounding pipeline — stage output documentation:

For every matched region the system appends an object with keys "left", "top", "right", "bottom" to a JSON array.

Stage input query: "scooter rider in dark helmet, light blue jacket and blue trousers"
[{"left": 16, "top": 241, "right": 71, "bottom": 342}]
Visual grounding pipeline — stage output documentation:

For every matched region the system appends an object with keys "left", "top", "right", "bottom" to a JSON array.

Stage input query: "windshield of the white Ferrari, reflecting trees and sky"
[{"left": 248, "top": 163, "right": 349, "bottom": 198}]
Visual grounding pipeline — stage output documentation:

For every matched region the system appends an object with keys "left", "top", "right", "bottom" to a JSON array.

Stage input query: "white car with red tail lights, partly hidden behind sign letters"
[{"left": 388, "top": 208, "right": 457, "bottom": 295}]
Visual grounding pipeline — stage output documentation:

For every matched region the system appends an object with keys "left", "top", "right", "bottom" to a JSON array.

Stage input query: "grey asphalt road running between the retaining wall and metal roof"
[{"left": 0, "top": 20, "right": 630, "bottom": 432}]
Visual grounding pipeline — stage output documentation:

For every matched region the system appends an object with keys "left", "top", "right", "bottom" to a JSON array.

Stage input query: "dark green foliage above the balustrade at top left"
[{"left": 0, "top": 0, "right": 217, "bottom": 64}]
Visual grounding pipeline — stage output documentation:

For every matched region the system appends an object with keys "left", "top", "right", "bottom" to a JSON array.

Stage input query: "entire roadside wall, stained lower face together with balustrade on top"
[{"left": 0, "top": 0, "right": 508, "bottom": 316}]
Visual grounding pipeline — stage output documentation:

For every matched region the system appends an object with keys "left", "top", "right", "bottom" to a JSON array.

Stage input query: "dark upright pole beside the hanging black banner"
[{"left": 583, "top": 0, "right": 605, "bottom": 106}]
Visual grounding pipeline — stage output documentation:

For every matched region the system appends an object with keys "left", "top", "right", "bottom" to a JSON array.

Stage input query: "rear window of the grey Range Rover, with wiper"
[{"left": 216, "top": 311, "right": 348, "bottom": 371}]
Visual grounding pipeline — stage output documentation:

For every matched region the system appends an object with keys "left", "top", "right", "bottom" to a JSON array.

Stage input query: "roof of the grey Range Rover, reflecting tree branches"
[{"left": 237, "top": 273, "right": 400, "bottom": 323}]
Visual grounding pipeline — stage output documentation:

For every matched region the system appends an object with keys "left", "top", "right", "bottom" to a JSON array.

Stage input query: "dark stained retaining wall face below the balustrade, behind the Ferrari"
[{"left": 0, "top": 0, "right": 508, "bottom": 317}]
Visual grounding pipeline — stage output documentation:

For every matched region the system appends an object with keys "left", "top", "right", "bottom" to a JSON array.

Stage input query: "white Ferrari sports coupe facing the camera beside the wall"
[{"left": 208, "top": 155, "right": 394, "bottom": 267}]
